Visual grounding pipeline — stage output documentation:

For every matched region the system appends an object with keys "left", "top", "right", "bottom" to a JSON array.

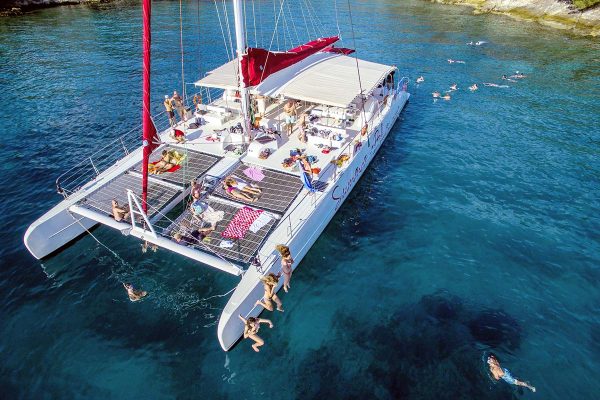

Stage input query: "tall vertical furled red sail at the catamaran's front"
[{"left": 142, "top": 0, "right": 156, "bottom": 214}]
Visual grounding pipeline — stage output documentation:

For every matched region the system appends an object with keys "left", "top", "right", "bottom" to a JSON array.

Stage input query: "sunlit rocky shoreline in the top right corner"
[{"left": 430, "top": 0, "right": 600, "bottom": 36}]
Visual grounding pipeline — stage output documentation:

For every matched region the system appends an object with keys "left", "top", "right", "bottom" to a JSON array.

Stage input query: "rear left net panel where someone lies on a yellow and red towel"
[{"left": 133, "top": 145, "right": 221, "bottom": 186}]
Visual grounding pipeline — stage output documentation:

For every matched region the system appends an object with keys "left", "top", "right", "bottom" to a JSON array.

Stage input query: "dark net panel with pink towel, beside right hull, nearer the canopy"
[{"left": 214, "top": 163, "right": 302, "bottom": 214}]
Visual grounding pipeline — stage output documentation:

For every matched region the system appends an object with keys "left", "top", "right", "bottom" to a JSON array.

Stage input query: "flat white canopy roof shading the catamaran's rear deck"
[{"left": 196, "top": 53, "right": 395, "bottom": 108}]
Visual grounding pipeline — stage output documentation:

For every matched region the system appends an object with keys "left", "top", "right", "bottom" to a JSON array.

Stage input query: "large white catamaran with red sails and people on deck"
[{"left": 24, "top": 0, "right": 410, "bottom": 351}]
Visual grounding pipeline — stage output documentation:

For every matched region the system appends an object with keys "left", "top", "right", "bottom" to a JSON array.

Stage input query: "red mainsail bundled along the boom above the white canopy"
[{"left": 241, "top": 36, "right": 339, "bottom": 86}]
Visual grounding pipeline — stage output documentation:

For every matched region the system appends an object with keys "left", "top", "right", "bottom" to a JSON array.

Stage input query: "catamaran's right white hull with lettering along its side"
[{"left": 218, "top": 92, "right": 410, "bottom": 351}]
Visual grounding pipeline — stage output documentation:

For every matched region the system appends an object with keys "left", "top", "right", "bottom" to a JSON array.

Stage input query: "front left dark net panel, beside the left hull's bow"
[{"left": 80, "top": 172, "right": 182, "bottom": 217}]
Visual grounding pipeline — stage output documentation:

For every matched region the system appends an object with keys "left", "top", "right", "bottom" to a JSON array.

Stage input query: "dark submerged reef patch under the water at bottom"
[{"left": 295, "top": 291, "right": 523, "bottom": 399}]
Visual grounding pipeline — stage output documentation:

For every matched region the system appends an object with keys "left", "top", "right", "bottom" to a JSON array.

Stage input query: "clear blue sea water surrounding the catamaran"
[{"left": 0, "top": 0, "right": 600, "bottom": 399}]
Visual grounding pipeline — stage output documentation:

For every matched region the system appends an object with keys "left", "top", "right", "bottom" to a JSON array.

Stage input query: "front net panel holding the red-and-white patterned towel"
[{"left": 163, "top": 196, "right": 279, "bottom": 264}]
